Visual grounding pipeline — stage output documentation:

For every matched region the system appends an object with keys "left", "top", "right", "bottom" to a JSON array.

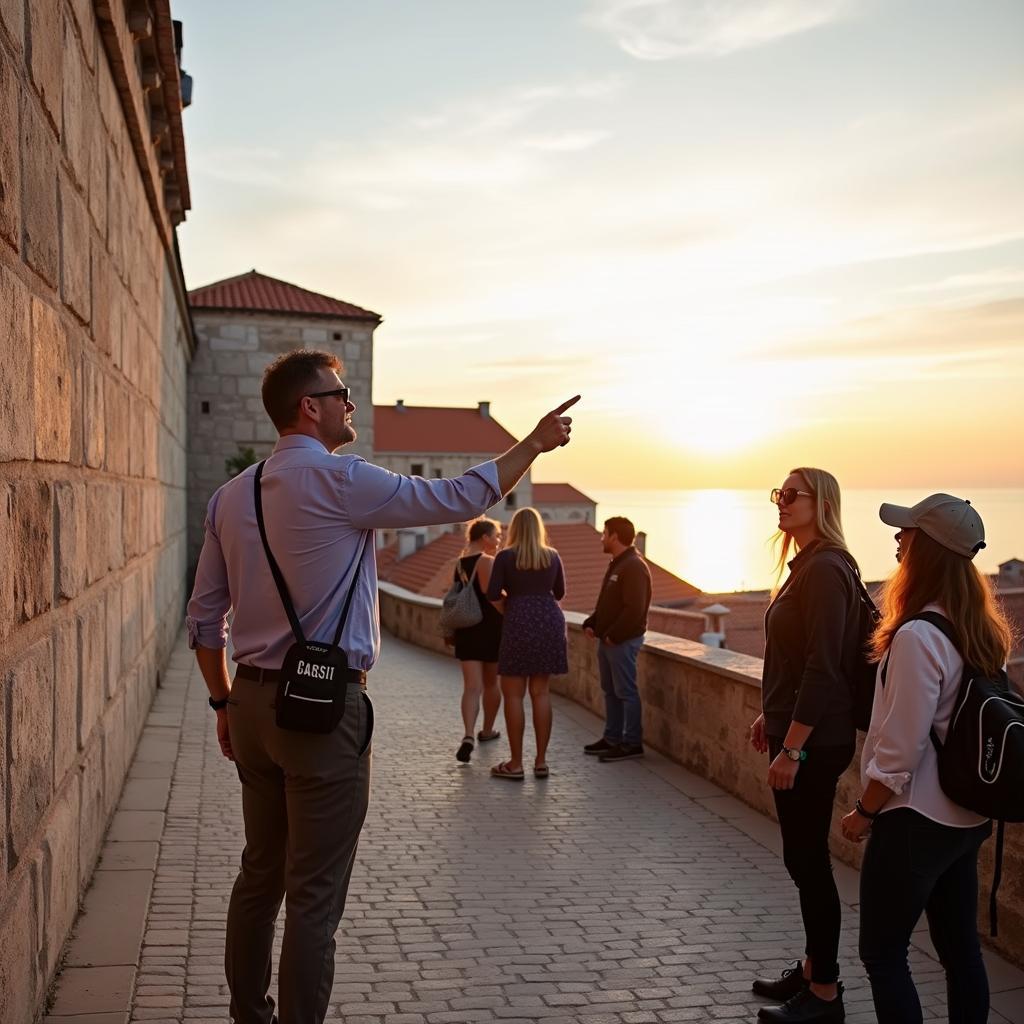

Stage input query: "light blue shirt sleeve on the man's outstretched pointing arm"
[{"left": 342, "top": 459, "right": 502, "bottom": 529}]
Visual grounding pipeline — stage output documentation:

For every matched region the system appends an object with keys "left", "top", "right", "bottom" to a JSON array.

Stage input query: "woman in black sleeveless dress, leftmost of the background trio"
[{"left": 453, "top": 518, "right": 502, "bottom": 763}]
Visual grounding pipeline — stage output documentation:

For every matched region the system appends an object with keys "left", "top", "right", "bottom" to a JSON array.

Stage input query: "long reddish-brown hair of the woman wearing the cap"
[{"left": 870, "top": 529, "right": 1014, "bottom": 675}]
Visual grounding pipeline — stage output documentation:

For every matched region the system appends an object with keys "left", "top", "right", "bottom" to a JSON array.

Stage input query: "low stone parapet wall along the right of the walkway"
[{"left": 382, "top": 583, "right": 1024, "bottom": 965}]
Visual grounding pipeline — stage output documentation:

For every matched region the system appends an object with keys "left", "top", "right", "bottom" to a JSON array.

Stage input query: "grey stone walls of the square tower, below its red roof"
[{"left": 188, "top": 309, "right": 374, "bottom": 566}]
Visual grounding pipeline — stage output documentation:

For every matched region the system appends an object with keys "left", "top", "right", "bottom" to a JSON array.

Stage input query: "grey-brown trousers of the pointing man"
[{"left": 224, "top": 678, "right": 374, "bottom": 1024}]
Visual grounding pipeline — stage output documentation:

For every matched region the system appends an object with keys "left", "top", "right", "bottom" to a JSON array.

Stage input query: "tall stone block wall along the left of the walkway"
[{"left": 0, "top": 0, "right": 191, "bottom": 1022}]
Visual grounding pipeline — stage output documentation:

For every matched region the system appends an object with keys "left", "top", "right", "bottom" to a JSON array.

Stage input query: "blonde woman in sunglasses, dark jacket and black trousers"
[{"left": 750, "top": 468, "right": 860, "bottom": 1021}]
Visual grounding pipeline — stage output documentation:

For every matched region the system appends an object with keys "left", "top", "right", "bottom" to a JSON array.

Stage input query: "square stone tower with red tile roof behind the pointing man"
[{"left": 187, "top": 270, "right": 381, "bottom": 565}]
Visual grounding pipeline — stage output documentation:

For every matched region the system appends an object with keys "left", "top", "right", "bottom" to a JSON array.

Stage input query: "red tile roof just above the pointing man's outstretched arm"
[{"left": 374, "top": 406, "right": 516, "bottom": 456}]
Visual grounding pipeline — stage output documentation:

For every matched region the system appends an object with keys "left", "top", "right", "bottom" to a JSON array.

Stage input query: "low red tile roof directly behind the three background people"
[{"left": 377, "top": 523, "right": 700, "bottom": 612}]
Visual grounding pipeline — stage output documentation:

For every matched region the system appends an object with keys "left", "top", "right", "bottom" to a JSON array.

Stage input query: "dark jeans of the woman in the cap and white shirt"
[{"left": 860, "top": 807, "right": 992, "bottom": 1024}]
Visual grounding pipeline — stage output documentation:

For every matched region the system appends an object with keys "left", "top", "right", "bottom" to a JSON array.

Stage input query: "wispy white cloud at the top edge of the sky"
[{"left": 590, "top": 0, "right": 854, "bottom": 60}]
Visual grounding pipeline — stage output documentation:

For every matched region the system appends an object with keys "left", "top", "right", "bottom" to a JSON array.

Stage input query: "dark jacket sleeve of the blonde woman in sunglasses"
[{"left": 793, "top": 558, "right": 849, "bottom": 726}]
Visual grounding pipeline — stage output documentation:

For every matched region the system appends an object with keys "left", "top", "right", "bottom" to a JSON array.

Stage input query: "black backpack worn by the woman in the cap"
[{"left": 882, "top": 611, "right": 1024, "bottom": 935}]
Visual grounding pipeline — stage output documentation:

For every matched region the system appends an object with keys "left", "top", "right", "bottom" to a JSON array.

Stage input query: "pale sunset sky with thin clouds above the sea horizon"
[{"left": 172, "top": 0, "right": 1024, "bottom": 487}]
